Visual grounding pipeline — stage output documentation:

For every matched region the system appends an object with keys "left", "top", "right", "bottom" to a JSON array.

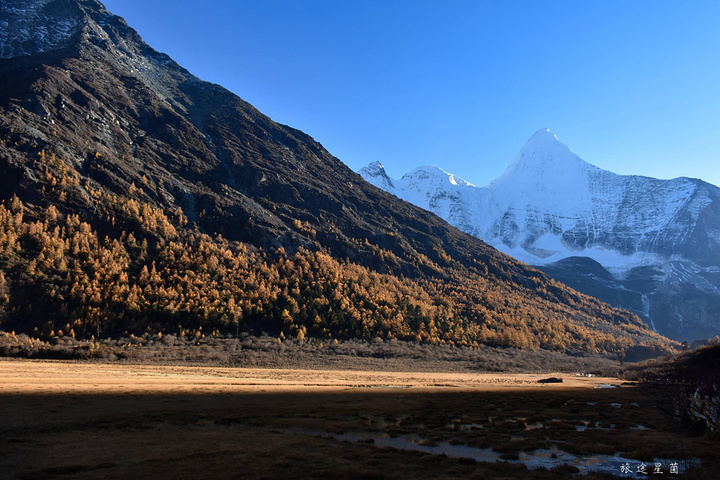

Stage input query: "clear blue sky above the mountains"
[{"left": 104, "top": 0, "right": 720, "bottom": 185}]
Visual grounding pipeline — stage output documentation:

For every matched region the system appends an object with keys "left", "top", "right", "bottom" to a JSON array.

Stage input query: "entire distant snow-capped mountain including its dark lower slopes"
[{"left": 359, "top": 129, "right": 720, "bottom": 340}]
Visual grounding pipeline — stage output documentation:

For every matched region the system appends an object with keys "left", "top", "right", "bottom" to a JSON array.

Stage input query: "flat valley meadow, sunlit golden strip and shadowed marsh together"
[{"left": 0, "top": 359, "right": 720, "bottom": 479}]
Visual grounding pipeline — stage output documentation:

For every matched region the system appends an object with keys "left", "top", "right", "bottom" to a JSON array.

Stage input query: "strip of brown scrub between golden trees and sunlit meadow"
[{"left": 0, "top": 331, "right": 618, "bottom": 373}]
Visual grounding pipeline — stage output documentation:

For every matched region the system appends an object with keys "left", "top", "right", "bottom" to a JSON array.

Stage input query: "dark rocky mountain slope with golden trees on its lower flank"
[{"left": 0, "top": 0, "right": 669, "bottom": 353}]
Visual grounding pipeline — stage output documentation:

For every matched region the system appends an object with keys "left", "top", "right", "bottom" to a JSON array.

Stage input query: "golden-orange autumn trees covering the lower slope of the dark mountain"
[{"left": 0, "top": 189, "right": 663, "bottom": 353}]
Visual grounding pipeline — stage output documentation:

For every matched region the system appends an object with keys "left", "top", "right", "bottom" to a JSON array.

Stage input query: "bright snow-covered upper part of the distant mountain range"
[{"left": 361, "top": 128, "right": 720, "bottom": 269}]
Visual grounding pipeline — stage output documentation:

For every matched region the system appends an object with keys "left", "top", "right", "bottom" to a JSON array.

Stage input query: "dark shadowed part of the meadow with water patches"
[{"left": 0, "top": 386, "right": 720, "bottom": 479}]
